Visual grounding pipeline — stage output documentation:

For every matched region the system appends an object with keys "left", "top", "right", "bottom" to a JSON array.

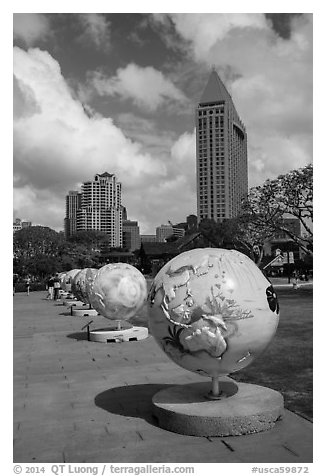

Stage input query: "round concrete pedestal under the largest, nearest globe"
[{"left": 152, "top": 377, "right": 284, "bottom": 436}]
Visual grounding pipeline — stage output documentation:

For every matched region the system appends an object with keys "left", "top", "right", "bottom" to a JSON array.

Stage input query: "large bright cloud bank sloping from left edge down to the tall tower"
[{"left": 14, "top": 47, "right": 195, "bottom": 233}]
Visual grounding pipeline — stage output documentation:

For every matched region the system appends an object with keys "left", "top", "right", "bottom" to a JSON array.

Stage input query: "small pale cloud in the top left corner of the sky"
[{"left": 13, "top": 13, "right": 50, "bottom": 46}]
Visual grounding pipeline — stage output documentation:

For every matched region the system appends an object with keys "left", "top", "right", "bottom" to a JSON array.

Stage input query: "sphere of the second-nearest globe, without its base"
[{"left": 90, "top": 263, "right": 147, "bottom": 320}]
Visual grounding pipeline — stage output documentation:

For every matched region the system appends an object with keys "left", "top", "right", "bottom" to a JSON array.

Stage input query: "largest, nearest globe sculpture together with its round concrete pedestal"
[{"left": 148, "top": 248, "right": 284, "bottom": 436}]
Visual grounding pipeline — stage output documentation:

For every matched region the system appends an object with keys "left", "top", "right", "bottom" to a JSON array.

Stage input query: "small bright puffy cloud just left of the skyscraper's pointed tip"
[{"left": 90, "top": 63, "right": 186, "bottom": 111}]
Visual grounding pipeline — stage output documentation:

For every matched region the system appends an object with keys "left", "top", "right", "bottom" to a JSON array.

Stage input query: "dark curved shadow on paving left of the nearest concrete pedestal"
[{"left": 94, "top": 384, "right": 171, "bottom": 426}]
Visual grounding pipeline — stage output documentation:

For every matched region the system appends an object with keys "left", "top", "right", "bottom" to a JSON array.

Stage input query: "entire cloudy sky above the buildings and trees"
[{"left": 13, "top": 13, "right": 312, "bottom": 233}]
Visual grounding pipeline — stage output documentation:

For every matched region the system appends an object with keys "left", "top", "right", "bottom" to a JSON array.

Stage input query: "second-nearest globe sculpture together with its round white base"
[{"left": 89, "top": 263, "right": 148, "bottom": 343}]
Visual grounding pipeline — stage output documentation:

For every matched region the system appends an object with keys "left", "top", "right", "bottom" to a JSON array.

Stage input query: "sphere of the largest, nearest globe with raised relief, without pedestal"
[{"left": 148, "top": 248, "right": 279, "bottom": 377}]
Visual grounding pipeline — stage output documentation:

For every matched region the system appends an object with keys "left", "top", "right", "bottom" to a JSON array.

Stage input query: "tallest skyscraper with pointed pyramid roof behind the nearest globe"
[{"left": 196, "top": 69, "right": 248, "bottom": 221}]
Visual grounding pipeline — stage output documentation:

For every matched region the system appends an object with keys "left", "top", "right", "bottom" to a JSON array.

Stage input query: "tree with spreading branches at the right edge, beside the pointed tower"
[{"left": 243, "top": 164, "right": 313, "bottom": 254}]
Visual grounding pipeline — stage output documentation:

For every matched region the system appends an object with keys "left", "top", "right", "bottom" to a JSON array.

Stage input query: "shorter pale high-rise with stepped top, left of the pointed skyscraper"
[{"left": 76, "top": 172, "right": 122, "bottom": 247}]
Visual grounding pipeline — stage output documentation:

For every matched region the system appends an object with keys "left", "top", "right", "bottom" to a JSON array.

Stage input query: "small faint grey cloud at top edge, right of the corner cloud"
[{"left": 79, "top": 13, "right": 110, "bottom": 50}]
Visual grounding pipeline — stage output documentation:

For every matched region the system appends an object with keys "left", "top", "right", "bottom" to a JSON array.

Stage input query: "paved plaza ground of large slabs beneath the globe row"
[{"left": 13, "top": 292, "right": 312, "bottom": 463}]
